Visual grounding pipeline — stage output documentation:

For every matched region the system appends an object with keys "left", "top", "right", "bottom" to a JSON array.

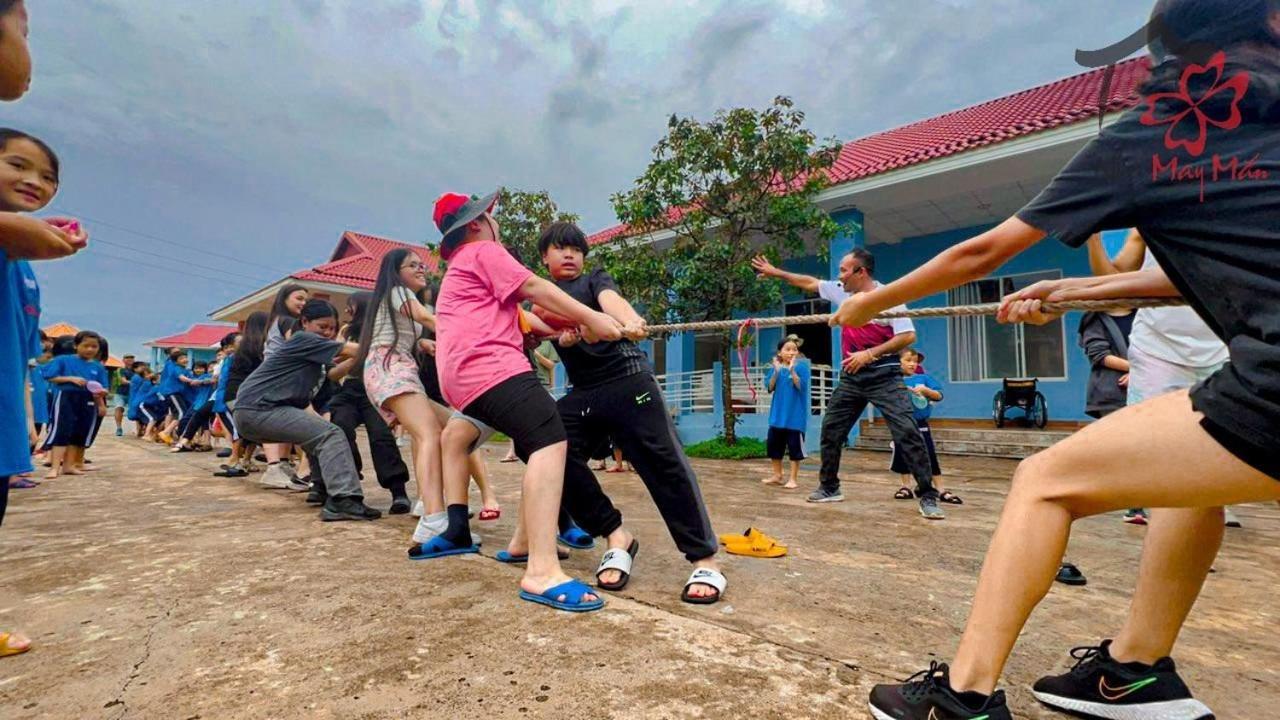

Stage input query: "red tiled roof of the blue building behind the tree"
[{"left": 588, "top": 58, "right": 1151, "bottom": 245}]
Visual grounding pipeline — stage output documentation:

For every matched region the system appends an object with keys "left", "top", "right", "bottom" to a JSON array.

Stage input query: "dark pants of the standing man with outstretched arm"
[{"left": 818, "top": 364, "right": 938, "bottom": 497}]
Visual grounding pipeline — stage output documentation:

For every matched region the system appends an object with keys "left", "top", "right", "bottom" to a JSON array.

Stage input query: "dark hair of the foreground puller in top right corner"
[{"left": 1142, "top": 0, "right": 1280, "bottom": 117}]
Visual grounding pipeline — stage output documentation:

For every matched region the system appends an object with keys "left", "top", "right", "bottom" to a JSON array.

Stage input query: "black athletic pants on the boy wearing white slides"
[{"left": 557, "top": 373, "right": 718, "bottom": 562}]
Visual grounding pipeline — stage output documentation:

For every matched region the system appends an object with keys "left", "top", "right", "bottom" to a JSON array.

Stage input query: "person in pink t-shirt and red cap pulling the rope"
[{"left": 413, "top": 193, "right": 625, "bottom": 612}]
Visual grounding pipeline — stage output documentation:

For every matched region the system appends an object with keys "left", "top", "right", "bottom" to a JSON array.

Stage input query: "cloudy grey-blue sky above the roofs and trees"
[{"left": 0, "top": 0, "right": 1149, "bottom": 355}]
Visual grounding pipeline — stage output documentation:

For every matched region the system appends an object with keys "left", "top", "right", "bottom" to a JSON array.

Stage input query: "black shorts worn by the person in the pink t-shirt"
[{"left": 462, "top": 370, "right": 568, "bottom": 462}]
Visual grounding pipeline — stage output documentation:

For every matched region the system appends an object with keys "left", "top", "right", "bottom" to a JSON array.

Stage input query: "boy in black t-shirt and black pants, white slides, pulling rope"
[{"left": 534, "top": 223, "right": 726, "bottom": 605}]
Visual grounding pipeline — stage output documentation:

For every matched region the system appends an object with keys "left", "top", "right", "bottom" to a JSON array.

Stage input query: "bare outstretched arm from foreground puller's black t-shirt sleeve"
[{"left": 831, "top": 212, "right": 1044, "bottom": 327}]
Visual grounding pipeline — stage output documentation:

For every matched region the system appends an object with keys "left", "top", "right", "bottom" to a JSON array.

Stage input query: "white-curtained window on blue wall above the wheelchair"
[{"left": 947, "top": 270, "right": 1066, "bottom": 383}]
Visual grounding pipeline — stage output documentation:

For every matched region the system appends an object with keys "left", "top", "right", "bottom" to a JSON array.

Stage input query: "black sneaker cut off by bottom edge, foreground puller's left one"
[{"left": 870, "top": 662, "right": 1012, "bottom": 720}]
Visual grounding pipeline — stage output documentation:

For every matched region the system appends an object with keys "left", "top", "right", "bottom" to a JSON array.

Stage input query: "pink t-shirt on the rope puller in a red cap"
[{"left": 435, "top": 241, "right": 534, "bottom": 410}]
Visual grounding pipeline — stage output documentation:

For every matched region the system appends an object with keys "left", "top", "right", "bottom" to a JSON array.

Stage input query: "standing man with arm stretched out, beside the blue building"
[{"left": 751, "top": 247, "right": 946, "bottom": 520}]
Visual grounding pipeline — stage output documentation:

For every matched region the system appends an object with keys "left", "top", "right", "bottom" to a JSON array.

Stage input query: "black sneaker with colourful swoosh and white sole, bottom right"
[{"left": 1032, "top": 641, "right": 1213, "bottom": 720}]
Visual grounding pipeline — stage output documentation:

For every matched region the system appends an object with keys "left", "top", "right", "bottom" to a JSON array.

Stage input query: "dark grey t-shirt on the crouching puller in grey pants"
[{"left": 236, "top": 332, "right": 343, "bottom": 410}]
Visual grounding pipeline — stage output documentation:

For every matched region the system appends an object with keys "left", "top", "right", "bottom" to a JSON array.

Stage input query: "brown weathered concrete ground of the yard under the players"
[{"left": 0, "top": 437, "right": 1280, "bottom": 720}]
